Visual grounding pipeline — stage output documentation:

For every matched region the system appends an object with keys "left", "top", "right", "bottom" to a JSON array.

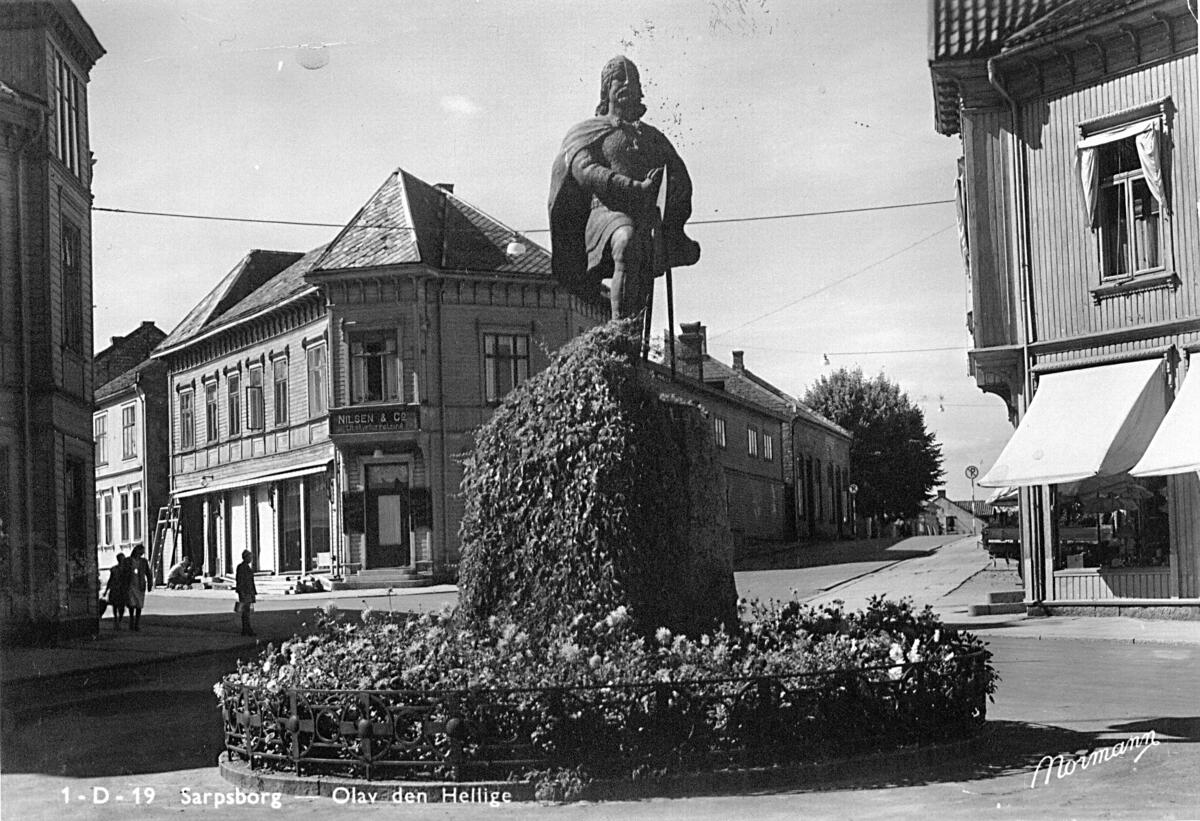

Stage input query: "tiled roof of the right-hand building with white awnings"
[{"left": 929, "top": 0, "right": 1070, "bottom": 61}]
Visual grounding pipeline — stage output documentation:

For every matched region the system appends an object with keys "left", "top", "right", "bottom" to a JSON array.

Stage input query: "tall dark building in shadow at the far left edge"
[{"left": 0, "top": 0, "right": 104, "bottom": 640}]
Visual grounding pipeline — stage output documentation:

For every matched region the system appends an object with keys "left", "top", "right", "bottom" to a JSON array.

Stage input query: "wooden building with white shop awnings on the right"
[{"left": 930, "top": 0, "right": 1200, "bottom": 617}]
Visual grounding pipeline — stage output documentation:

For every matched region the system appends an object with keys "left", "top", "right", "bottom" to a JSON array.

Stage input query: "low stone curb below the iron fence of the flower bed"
[{"left": 217, "top": 725, "right": 992, "bottom": 807}]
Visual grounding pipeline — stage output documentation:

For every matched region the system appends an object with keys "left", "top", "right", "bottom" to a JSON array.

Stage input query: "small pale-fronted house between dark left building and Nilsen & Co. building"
[{"left": 91, "top": 322, "right": 170, "bottom": 582}]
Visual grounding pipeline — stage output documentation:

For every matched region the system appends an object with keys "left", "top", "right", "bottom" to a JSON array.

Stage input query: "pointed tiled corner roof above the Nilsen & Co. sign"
[{"left": 316, "top": 168, "right": 550, "bottom": 277}]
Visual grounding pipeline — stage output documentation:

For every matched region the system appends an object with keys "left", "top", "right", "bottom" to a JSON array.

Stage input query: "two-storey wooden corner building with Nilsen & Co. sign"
[{"left": 155, "top": 169, "right": 608, "bottom": 587}]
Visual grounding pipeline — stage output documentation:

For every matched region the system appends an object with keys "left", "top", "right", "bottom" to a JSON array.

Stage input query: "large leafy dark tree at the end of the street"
[{"left": 804, "top": 367, "right": 944, "bottom": 521}]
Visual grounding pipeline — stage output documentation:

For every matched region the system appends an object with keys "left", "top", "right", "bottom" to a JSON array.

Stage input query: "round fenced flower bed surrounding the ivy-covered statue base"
[{"left": 215, "top": 600, "right": 996, "bottom": 784}]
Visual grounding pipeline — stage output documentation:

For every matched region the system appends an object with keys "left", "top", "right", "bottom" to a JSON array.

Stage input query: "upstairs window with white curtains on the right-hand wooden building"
[{"left": 1076, "top": 114, "right": 1170, "bottom": 280}]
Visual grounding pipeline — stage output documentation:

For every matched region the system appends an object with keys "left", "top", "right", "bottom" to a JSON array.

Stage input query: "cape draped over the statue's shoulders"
[{"left": 550, "top": 116, "right": 700, "bottom": 288}]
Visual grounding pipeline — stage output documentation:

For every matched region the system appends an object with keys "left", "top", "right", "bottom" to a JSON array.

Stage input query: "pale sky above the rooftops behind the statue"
[{"left": 76, "top": 0, "right": 1012, "bottom": 499}]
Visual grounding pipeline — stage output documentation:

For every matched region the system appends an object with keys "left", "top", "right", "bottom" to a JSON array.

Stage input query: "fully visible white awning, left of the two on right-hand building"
[{"left": 979, "top": 359, "right": 1166, "bottom": 487}]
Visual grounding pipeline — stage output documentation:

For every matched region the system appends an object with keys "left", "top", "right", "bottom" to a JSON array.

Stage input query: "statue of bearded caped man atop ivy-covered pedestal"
[{"left": 550, "top": 56, "right": 700, "bottom": 319}]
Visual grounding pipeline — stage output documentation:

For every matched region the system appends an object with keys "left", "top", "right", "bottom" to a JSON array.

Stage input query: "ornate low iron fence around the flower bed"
[{"left": 221, "top": 651, "right": 990, "bottom": 780}]
